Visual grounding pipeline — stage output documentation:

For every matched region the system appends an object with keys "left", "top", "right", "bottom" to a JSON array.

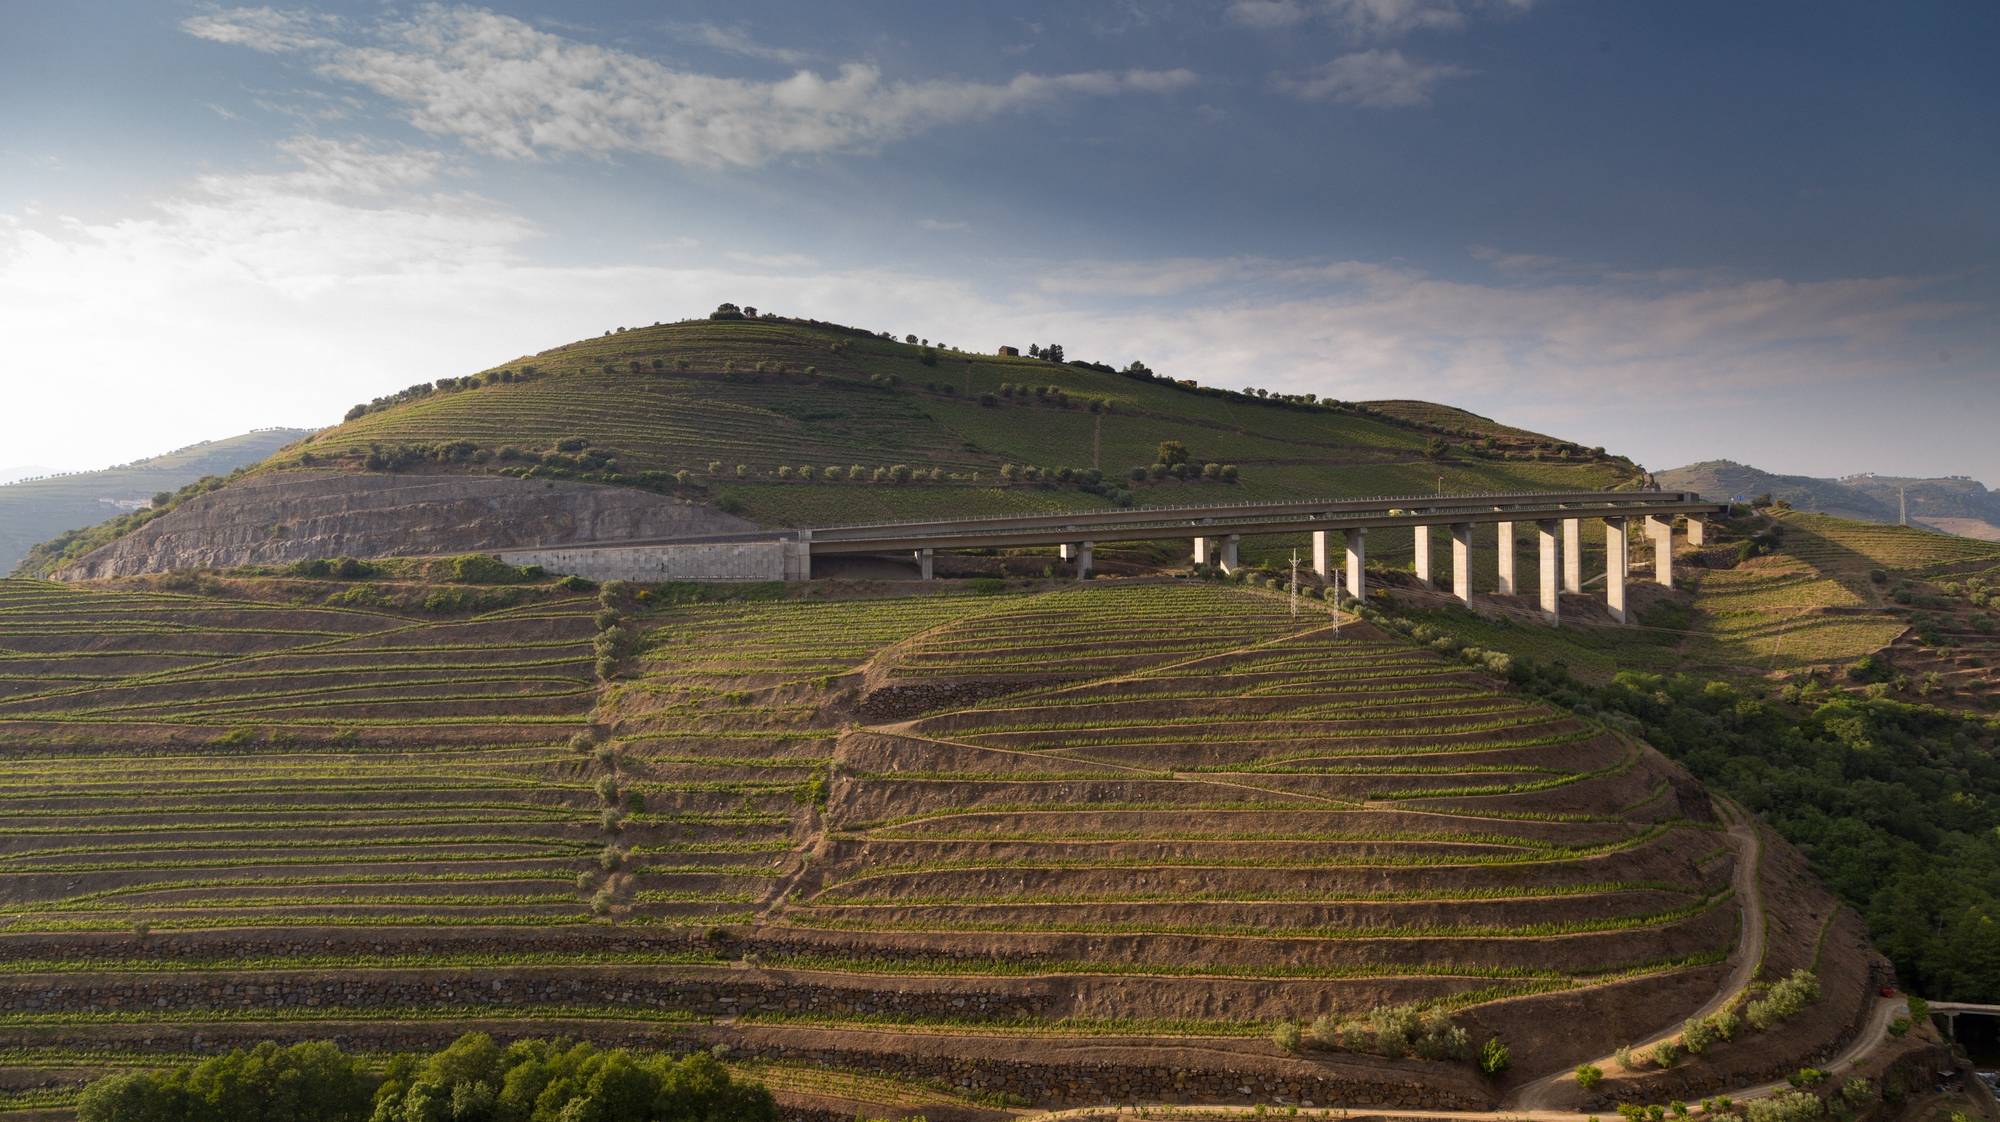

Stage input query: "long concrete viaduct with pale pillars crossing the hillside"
[{"left": 500, "top": 490, "right": 1722, "bottom": 622}]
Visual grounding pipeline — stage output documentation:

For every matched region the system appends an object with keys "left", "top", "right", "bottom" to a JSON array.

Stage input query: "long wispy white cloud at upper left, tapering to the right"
[{"left": 182, "top": 6, "right": 1196, "bottom": 168}]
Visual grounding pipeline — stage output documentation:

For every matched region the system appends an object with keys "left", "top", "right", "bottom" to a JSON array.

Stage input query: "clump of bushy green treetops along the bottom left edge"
[{"left": 76, "top": 1032, "right": 778, "bottom": 1122}]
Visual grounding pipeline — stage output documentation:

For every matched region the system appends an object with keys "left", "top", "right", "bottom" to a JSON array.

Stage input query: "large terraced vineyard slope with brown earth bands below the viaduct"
[{"left": 0, "top": 582, "right": 1862, "bottom": 1114}]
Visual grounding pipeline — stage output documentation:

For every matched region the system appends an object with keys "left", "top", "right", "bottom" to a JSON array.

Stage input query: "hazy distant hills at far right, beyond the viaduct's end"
[{"left": 1658, "top": 460, "right": 2000, "bottom": 540}]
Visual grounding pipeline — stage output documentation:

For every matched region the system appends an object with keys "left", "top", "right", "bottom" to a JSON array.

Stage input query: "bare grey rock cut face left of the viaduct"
[{"left": 56, "top": 472, "right": 758, "bottom": 580}]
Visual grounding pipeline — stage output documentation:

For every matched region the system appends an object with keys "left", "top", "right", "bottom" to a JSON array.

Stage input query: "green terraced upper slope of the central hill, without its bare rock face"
[{"left": 272, "top": 320, "right": 1630, "bottom": 524}]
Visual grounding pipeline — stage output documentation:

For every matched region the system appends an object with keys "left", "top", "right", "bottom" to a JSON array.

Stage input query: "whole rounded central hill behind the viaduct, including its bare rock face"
[{"left": 38, "top": 312, "right": 1640, "bottom": 576}]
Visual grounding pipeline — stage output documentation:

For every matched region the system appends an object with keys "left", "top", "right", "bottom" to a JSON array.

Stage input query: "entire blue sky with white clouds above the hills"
[{"left": 0, "top": 0, "right": 2000, "bottom": 482}]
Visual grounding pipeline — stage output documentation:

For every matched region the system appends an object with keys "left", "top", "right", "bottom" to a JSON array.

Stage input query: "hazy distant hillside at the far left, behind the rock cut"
[{"left": 0, "top": 428, "right": 312, "bottom": 572}]
